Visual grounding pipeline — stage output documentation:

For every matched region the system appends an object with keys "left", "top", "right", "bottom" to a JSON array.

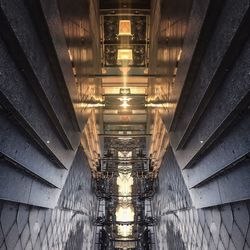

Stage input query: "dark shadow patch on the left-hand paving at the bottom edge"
[{"left": 64, "top": 221, "right": 84, "bottom": 250}]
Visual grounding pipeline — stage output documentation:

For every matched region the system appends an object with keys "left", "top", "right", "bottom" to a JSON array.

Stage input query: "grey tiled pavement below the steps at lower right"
[{"left": 153, "top": 146, "right": 250, "bottom": 250}]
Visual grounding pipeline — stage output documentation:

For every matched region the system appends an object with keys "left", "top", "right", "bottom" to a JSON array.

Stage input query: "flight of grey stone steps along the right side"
[{"left": 156, "top": 0, "right": 250, "bottom": 207}]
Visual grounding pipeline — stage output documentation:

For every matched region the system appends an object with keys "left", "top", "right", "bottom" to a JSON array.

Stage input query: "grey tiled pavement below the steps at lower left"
[{"left": 0, "top": 148, "right": 96, "bottom": 250}]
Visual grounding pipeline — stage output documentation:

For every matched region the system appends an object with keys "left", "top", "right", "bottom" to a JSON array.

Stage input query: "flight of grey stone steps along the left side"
[{"left": 0, "top": 0, "right": 96, "bottom": 208}]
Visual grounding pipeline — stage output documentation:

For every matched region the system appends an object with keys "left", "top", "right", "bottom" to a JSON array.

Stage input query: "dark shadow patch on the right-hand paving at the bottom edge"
[{"left": 166, "top": 221, "right": 186, "bottom": 250}]
